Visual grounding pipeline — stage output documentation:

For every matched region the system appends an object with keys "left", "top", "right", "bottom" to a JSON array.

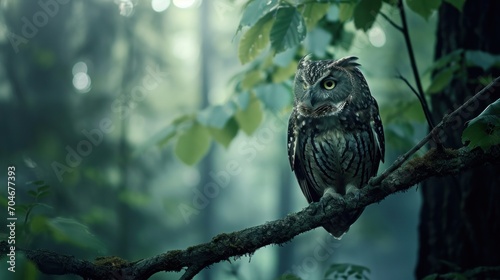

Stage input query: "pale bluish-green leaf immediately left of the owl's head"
[{"left": 255, "top": 84, "right": 292, "bottom": 111}]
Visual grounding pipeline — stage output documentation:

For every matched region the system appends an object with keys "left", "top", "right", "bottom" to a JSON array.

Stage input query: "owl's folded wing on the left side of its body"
[{"left": 287, "top": 110, "right": 321, "bottom": 203}]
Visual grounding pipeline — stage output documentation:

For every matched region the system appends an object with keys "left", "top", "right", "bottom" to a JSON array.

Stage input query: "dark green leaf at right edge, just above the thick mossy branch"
[{"left": 462, "top": 99, "right": 500, "bottom": 151}]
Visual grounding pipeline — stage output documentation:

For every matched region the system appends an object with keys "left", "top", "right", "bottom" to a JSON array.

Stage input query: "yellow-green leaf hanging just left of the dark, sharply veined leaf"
[{"left": 238, "top": 15, "right": 274, "bottom": 64}]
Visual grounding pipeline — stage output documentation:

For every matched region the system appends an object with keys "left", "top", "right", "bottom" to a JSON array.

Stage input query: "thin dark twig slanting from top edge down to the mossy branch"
[{"left": 398, "top": 0, "right": 441, "bottom": 131}]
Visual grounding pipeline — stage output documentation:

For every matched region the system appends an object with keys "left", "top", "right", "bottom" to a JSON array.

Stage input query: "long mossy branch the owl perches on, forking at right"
[{"left": 0, "top": 77, "right": 500, "bottom": 280}]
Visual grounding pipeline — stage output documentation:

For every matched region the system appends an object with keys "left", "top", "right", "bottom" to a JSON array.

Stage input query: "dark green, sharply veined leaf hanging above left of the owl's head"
[{"left": 270, "top": 6, "right": 307, "bottom": 52}]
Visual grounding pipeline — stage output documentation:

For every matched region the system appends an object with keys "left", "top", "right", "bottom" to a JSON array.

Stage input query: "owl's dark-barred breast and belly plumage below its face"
[{"left": 295, "top": 112, "right": 379, "bottom": 197}]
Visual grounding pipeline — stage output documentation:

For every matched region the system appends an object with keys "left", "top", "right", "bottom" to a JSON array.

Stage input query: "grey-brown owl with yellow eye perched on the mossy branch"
[{"left": 288, "top": 56, "right": 385, "bottom": 238}]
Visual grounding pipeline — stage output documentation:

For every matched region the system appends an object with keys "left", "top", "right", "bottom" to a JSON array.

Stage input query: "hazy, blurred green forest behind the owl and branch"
[{"left": 0, "top": 0, "right": 436, "bottom": 280}]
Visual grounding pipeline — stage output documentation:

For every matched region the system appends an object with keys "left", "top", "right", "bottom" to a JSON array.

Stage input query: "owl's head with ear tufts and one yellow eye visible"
[{"left": 294, "top": 56, "right": 369, "bottom": 117}]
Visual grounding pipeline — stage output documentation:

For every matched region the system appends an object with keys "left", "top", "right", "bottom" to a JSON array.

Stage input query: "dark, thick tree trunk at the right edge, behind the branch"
[{"left": 416, "top": 0, "right": 500, "bottom": 279}]
